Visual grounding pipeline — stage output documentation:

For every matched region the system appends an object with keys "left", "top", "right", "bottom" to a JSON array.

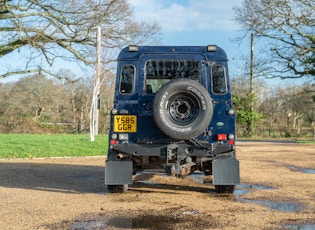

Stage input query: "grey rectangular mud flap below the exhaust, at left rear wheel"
[{"left": 105, "top": 160, "right": 133, "bottom": 185}]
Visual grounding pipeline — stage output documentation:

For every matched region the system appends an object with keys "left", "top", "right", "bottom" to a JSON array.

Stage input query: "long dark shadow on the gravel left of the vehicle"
[{"left": 0, "top": 162, "right": 108, "bottom": 193}]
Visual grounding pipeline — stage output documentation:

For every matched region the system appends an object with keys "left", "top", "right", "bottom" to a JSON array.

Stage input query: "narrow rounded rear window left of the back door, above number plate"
[{"left": 119, "top": 65, "right": 135, "bottom": 94}]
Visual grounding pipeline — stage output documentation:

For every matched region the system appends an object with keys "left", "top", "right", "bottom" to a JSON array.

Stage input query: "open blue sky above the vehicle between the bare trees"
[{"left": 127, "top": 0, "right": 300, "bottom": 86}]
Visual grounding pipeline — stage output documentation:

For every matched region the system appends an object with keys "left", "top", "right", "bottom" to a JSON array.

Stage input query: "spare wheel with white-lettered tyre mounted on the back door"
[{"left": 153, "top": 79, "right": 213, "bottom": 140}]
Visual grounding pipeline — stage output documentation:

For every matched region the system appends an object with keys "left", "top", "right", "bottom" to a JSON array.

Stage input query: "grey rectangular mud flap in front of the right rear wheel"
[{"left": 212, "top": 155, "right": 240, "bottom": 185}]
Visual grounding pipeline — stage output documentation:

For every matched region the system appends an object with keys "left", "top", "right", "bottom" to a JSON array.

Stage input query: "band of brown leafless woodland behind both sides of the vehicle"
[{"left": 0, "top": 72, "right": 315, "bottom": 138}]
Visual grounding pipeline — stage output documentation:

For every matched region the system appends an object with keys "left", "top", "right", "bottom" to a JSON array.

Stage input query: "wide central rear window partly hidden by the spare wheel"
[{"left": 145, "top": 60, "right": 201, "bottom": 94}]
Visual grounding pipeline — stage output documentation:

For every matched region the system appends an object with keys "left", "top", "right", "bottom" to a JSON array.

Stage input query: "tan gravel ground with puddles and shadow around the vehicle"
[{"left": 0, "top": 142, "right": 315, "bottom": 229}]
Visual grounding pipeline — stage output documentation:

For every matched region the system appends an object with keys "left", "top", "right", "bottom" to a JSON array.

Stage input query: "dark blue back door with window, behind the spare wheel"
[{"left": 137, "top": 54, "right": 208, "bottom": 143}]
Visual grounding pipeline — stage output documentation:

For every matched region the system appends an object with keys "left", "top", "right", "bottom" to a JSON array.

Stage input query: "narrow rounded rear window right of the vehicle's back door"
[{"left": 211, "top": 65, "right": 227, "bottom": 94}]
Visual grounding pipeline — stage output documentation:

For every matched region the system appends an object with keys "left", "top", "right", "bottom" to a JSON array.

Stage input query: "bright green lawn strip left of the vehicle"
[{"left": 0, "top": 134, "right": 108, "bottom": 158}]
